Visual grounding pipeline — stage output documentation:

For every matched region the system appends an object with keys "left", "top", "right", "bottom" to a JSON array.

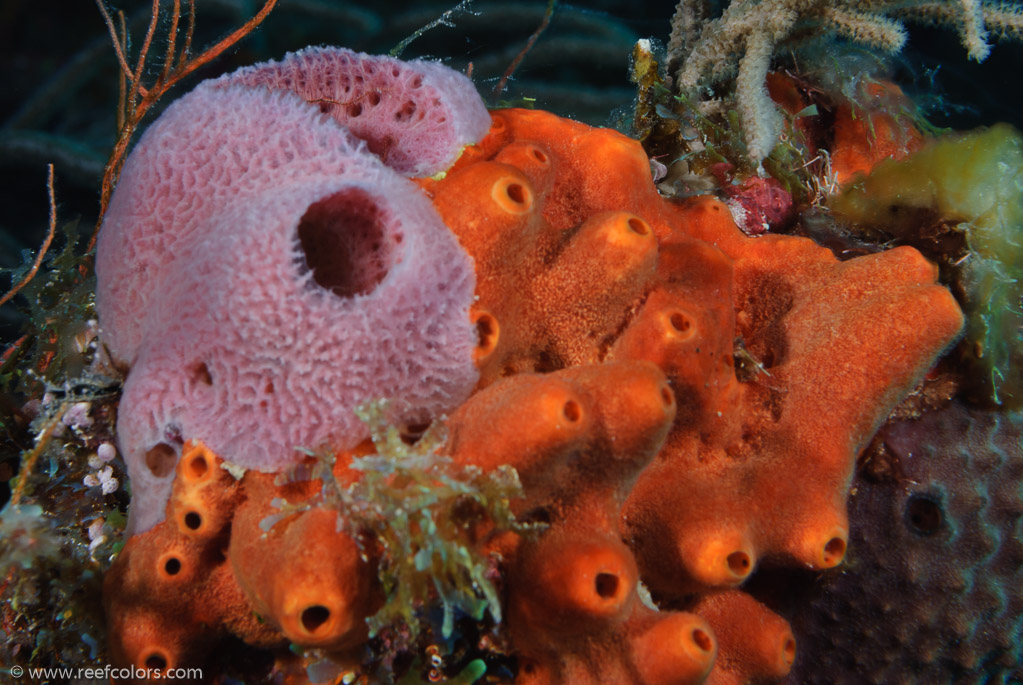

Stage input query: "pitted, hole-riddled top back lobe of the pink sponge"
[{"left": 214, "top": 47, "right": 490, "bottom": 177}]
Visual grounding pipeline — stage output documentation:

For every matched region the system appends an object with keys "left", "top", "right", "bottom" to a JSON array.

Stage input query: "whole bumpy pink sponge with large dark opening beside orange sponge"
[{"left": 96, "top": 48, "right": 490, "bottom": 534}]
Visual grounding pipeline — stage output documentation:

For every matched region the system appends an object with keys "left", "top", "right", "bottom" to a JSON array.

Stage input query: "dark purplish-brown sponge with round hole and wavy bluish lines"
[{"left": 791, "top": 401, "right": 1023, "bottom": 685}]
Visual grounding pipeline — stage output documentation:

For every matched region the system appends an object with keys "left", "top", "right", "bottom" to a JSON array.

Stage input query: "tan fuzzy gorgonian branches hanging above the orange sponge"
[{"left": 667, "top": 0, "right": 1023, "bottom": 168}]
